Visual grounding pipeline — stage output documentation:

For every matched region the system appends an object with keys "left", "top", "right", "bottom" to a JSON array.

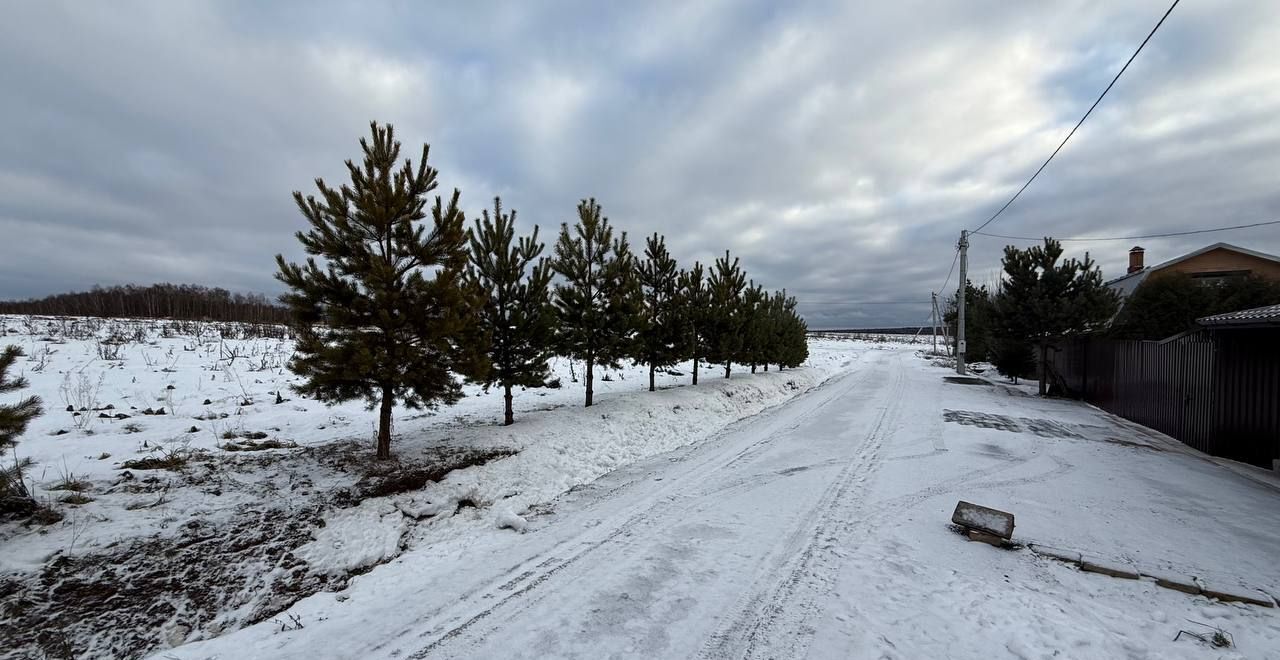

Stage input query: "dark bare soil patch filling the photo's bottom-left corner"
[{"left": 0, "top": 508, "right": 325, "bottom": 657}]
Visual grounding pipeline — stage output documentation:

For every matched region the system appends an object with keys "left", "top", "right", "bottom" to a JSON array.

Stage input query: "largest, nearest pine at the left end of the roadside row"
[{"left": 275, "top": 123, "right": 471, "bottom": 459}]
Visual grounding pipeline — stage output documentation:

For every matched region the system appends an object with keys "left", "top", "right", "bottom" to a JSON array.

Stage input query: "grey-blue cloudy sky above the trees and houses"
[{"left": 0, "top": 0, "right": 1280, "bottom": 327}]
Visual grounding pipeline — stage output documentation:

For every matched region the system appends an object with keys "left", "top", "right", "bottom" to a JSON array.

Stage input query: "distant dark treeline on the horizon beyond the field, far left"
[{"left": 0, "top": 284, "right": 289, "bottom": 324}]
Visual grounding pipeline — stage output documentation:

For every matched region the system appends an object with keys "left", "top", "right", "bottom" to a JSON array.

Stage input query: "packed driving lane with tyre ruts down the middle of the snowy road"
[{"left": 387, "top": 352, "right": 906, "bottom": 657}]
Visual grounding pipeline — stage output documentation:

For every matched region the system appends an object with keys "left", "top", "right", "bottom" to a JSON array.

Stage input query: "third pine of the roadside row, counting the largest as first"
[{"left": 553, "top": 198, "right": 640, "bottom": 405}]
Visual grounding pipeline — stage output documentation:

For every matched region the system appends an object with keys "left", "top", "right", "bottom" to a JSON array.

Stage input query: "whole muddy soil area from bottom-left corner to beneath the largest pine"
[{"left": 0, "top": 440, "right": 516, "bottom": 657}]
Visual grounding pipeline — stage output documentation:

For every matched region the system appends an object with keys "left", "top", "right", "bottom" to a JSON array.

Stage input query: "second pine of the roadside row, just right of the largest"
[{"left": 466, "top": 197, "right": 556, "bottom": 426}]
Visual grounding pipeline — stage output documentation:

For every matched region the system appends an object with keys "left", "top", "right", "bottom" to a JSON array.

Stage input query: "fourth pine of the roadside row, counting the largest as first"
[{"left": 635, "top": 232, "right": 684, "bottom": 391}]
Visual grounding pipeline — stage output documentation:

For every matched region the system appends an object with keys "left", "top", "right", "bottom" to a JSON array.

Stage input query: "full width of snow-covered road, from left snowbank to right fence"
[{"left": 161, "top": 348, "right": 1280, "bottom": 659}]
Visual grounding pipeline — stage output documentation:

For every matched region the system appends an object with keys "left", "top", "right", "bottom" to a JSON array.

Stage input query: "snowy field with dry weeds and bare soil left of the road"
[{"left": 0, "top": 317, "right": 856, "bottom": 657}]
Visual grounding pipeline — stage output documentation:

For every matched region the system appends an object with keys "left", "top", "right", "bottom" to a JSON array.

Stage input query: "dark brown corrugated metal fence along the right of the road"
[{"left": 1050, "top": 329, "right": 1280, "bottom": 468}]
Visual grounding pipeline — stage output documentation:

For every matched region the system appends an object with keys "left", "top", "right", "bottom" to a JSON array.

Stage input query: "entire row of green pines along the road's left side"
[{"left": 276, "top": 123, "right": 808, "bottom": 458}]
